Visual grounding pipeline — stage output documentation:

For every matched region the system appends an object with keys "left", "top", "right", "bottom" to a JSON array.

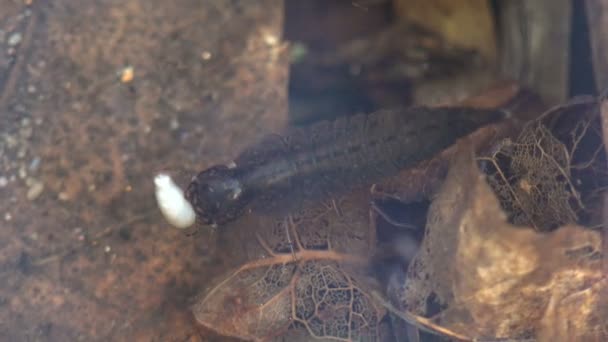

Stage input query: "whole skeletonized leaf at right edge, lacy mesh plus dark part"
[{"left": 480, "top": 97, "right": 606, "bottom": 231}]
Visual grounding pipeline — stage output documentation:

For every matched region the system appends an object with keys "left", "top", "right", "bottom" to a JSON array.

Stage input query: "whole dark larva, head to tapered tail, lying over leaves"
[{"left": 187, "top": 107, "right": 504, "bottom": 224}]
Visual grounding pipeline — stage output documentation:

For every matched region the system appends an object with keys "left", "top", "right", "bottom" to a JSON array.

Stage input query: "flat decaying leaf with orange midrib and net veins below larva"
[{"left": 194, "top": 191, "right": 384, "bottom": 341}]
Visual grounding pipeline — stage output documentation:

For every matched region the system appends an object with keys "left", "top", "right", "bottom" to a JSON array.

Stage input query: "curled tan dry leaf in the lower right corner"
[{"left": 399, "top": 142, "right": 608, "bottom": 341}]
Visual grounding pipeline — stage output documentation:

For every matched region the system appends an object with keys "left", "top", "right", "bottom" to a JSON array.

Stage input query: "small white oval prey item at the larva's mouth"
[{"left": 154, "top": 173, "right": 196, "bottom": 229}]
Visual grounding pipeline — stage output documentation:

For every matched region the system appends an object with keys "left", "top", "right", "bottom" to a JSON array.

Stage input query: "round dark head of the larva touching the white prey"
[{"left": 186, "top": 165, "right": 248, "bottom": 225}]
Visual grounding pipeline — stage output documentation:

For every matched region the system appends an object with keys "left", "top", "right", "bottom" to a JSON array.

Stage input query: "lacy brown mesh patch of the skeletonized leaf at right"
[{"left": 487, "top": 123, "right": 582, "bottom": 230}]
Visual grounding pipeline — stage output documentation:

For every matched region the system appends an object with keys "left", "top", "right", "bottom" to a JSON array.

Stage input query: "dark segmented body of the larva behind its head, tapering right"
[{"left": 236, "top": 107, "right": 504, "bottom": 197}]
